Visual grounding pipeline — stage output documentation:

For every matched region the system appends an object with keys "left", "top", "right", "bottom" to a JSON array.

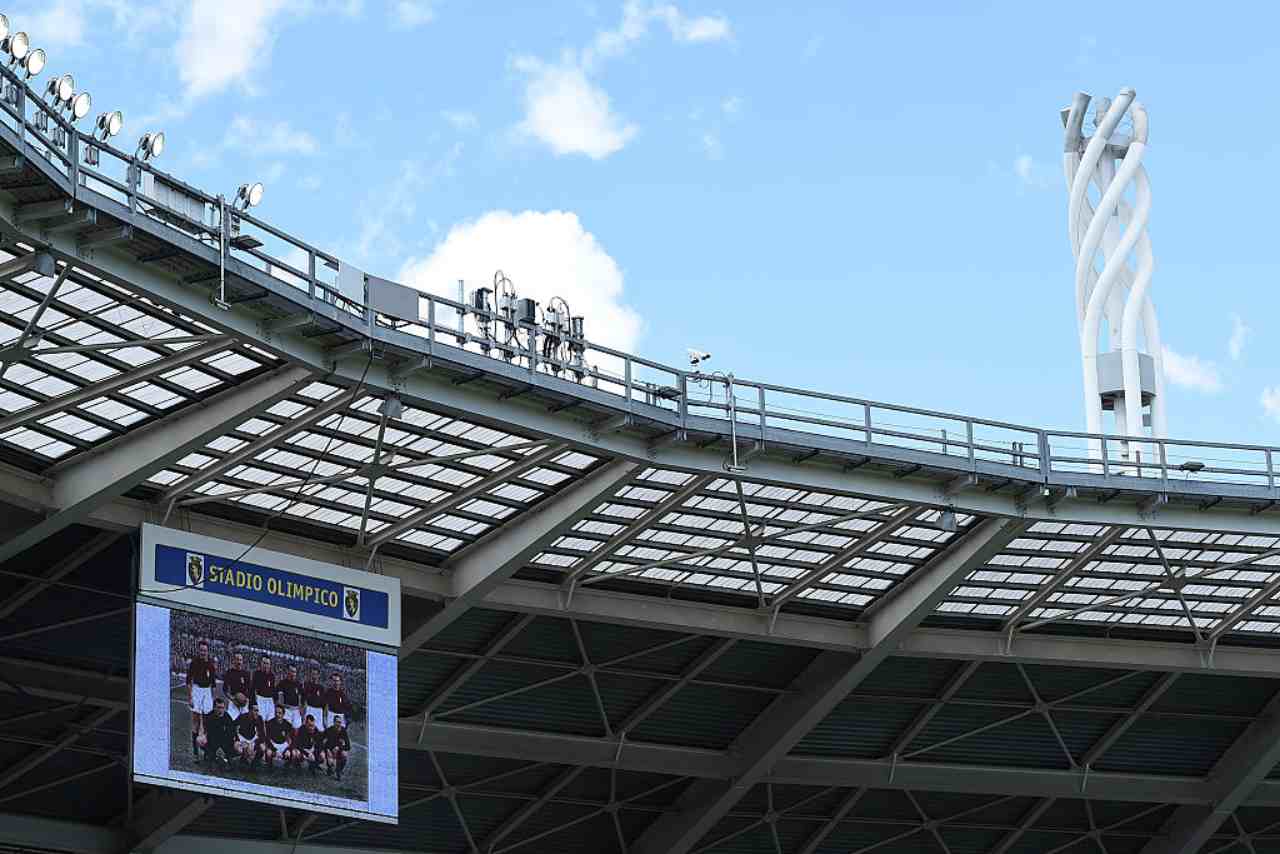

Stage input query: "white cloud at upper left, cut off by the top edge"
[{"left": 173, "top": 0, "right": 296, "bottom": 100}]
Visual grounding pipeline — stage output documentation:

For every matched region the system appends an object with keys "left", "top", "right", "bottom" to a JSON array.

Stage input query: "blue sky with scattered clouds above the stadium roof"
[{"left": 17, "top": 0, "right": 1280, "bottom": 443}]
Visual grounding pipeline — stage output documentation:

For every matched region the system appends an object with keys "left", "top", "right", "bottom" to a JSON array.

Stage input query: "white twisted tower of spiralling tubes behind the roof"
[{"left": 1062, "top": 88, "right": 1166, "bottom": 457}]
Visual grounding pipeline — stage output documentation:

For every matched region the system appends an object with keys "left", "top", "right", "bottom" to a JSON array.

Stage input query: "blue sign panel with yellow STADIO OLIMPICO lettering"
[{"left": 151, "top": 543, "right": 390, "bottom": 629}]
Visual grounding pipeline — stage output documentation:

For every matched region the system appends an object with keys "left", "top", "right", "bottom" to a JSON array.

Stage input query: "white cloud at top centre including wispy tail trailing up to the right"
[{"left": 513, "top": 1, "right": 731, "bottom": 160}]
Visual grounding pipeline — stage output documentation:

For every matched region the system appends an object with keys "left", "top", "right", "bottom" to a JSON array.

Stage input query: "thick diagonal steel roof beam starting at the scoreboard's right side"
[{"left": 399, "top": 460, "right": 639, "bottom": 658}]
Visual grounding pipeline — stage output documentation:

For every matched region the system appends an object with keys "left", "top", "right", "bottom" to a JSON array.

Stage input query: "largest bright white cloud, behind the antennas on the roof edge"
[{"left": 397, "top": 210, "right": 643, "bottom": 351}]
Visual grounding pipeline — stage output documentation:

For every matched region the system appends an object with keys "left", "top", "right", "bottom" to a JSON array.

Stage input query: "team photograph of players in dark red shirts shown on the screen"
[{"left": 169, "top": 611, "right": 369, "bottom": 800}]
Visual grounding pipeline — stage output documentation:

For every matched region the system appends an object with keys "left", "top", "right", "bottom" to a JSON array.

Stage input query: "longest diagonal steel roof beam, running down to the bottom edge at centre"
[{"left": 632, "top": 519, "right": 1024, "bottom": 854}]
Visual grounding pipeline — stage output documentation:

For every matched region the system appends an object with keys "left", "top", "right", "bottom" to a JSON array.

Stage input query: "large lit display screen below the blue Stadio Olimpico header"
[{"left": 133, "top": 602, "right": 398, "bottom": 822}]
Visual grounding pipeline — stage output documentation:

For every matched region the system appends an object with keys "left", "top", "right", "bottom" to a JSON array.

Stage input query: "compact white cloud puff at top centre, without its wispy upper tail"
[{"left": 516, "top": 58, "right": 637, "bottom": 160}]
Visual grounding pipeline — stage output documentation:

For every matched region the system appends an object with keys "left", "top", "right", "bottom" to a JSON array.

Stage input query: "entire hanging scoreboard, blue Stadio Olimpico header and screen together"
[{"left": 132, "top": 525, "right": 399, "bottom": 822}]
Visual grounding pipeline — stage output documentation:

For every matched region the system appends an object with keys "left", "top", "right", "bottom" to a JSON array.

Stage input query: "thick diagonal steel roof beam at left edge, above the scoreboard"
[{"left": 0, "top": 366, "right": 311, "bottom": 563}]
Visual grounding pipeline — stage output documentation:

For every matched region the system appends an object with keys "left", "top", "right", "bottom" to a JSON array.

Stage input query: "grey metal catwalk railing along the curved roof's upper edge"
[{"left": 0, "top": 67, "right": 1280, "bottom": 501}]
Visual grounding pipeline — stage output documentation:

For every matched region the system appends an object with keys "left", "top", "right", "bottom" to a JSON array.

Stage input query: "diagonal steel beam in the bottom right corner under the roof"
[{"left": 1142, "top": 694, "right": 1280, "bottom": 854}]
